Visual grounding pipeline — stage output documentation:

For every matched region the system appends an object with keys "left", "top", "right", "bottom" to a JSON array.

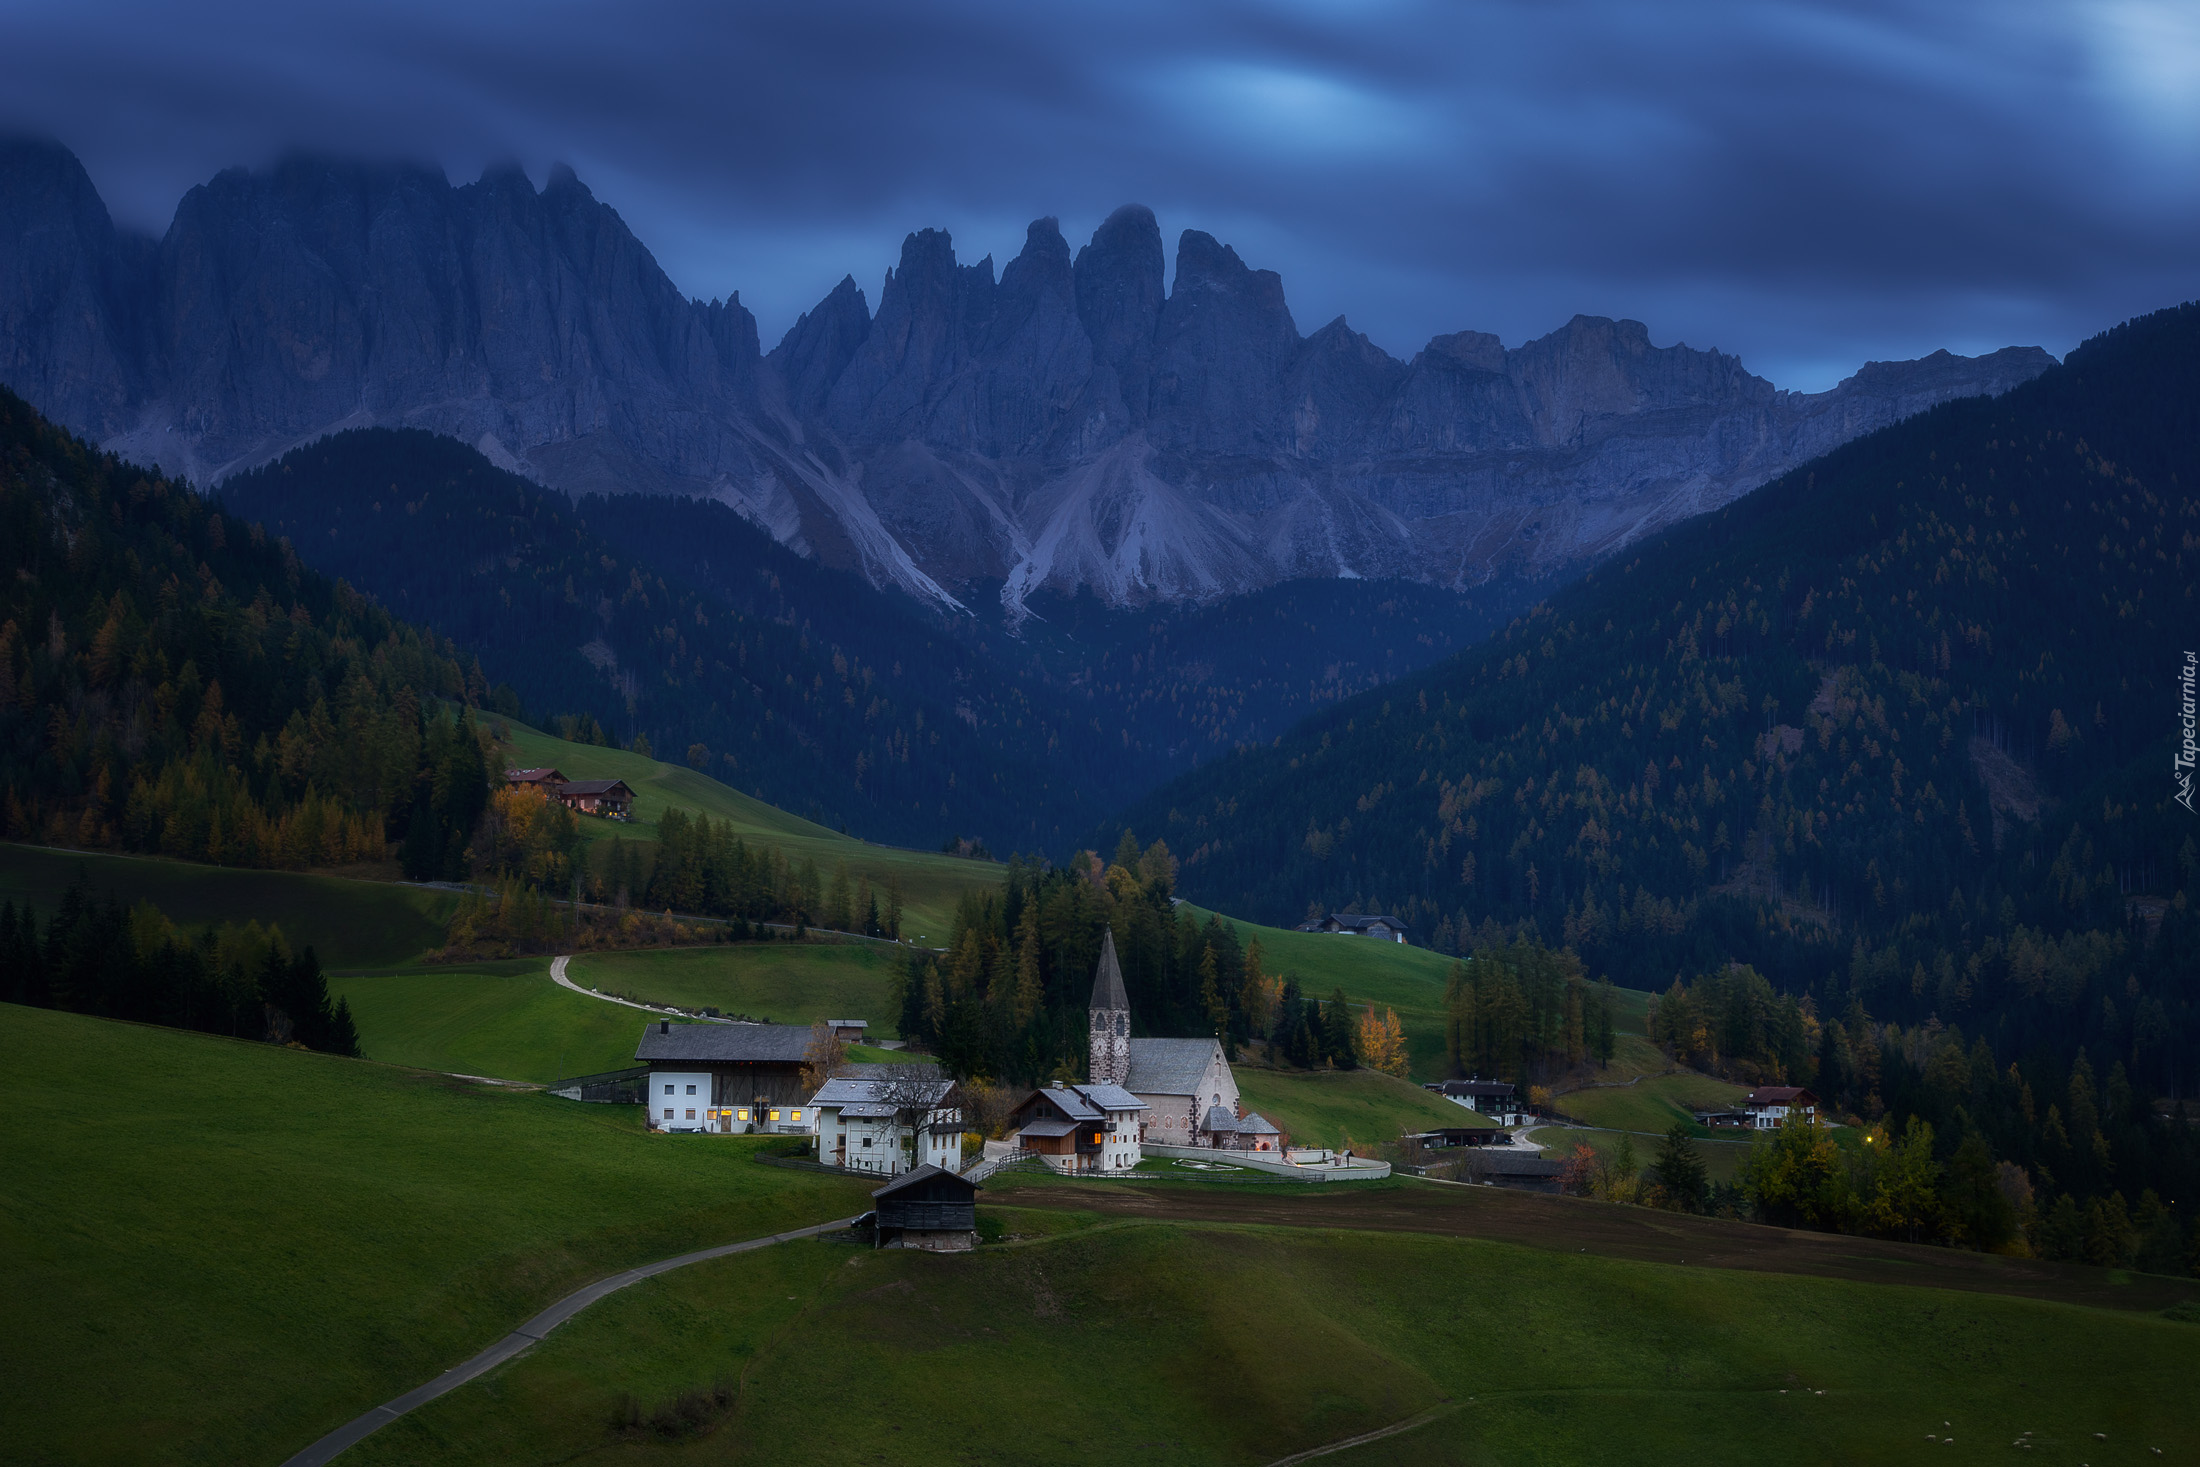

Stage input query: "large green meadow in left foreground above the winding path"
[{"left": 0, "top": 999, "right": 862, "bottom": 1463}]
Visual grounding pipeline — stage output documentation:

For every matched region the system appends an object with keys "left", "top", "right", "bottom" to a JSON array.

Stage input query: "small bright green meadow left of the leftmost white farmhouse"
[{"left": 328, "top": 957, "right": 647, "bottom": 1082}]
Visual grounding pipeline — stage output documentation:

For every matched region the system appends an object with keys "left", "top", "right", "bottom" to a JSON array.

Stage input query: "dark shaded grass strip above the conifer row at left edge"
[{"left": 0, "top": 842, "right": 458, "bottom": 968}]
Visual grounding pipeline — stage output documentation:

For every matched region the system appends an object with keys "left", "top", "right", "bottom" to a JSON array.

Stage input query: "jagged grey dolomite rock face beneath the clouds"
[{"left": 0, "top": 141, "right": 2053, "bottom": 609}]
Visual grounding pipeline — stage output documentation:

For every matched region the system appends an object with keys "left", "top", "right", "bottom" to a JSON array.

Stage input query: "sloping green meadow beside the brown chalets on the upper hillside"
[{"left": 510, "top": 724, "right": 1001, "bottom": 944}]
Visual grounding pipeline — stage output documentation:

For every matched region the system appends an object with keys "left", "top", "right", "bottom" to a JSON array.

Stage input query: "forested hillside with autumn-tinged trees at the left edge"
[{"left": 0, "top": 391, "right": 488, "bottom": 878}]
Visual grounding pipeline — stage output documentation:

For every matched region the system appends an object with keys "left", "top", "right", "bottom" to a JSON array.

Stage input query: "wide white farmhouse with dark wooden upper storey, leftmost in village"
[{"left": 634, "top": 1018, "right": 810, "bottom": 1135}]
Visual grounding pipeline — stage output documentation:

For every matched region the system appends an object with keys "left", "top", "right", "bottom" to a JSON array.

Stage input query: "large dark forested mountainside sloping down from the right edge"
[{"left": 1129, "top": 306, "right": 2200, "bottom": 1192}]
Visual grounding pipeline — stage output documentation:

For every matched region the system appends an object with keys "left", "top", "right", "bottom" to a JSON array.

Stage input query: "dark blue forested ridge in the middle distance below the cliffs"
[{"left": 222, "top": 429, "right": 1122, "bottom": 845}]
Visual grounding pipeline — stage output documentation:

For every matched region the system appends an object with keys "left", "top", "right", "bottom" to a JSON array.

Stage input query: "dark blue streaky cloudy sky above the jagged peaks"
[{"left": 0, "top": 0, "right": 2200, "bottom": 387}]
